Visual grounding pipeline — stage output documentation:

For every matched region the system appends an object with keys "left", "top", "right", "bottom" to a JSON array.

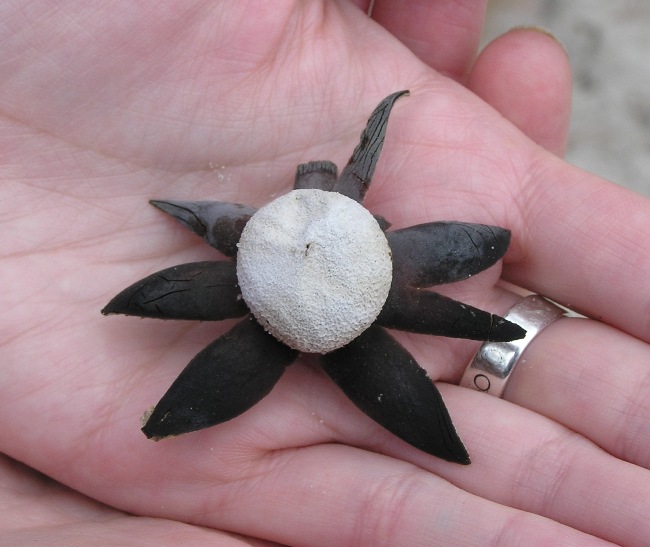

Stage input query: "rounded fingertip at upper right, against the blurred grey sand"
[{"left": 467, "top": 29, "right": 571, "bottom": 156}]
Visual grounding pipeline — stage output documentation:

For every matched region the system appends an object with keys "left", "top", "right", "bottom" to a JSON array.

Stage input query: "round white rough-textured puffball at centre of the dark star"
[{"left": 237, "top": 190, "right": 393, "bottom": 353}]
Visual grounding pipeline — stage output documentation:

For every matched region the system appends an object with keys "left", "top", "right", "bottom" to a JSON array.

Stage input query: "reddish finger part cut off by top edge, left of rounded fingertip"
[{"left": 372, "top": 0, "right": 486, "bottom": 81}]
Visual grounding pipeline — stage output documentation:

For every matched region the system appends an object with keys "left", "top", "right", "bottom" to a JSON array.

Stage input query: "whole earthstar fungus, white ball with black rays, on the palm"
[{"left": 102, "top": 91, "right": 525, "bottom": 464}]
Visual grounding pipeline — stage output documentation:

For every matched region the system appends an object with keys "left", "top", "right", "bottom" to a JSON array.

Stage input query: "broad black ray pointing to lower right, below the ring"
[{"left": 321, "top": 326, "right": 470, "bottom": 465}]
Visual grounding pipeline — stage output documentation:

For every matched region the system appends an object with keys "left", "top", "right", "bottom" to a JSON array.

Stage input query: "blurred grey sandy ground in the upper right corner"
[{"left": 484, "top": 0, "right": 650, "bottom": 196}]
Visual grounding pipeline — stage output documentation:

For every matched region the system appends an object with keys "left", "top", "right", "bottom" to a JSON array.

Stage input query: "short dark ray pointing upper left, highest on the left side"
[{"left": 149, "top": 200, "right": 256, "bottom": 256}]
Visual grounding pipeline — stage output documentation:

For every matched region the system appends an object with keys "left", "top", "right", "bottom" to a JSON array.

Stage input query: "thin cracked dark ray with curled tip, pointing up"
[{"left": 334, "top": 90, "right": 408, "bottom": 203}]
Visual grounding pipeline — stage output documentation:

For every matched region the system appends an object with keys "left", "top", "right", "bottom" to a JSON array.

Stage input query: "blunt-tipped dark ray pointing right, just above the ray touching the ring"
[{"left": 386, "top": 222, "right": 510, "bottom": 287}]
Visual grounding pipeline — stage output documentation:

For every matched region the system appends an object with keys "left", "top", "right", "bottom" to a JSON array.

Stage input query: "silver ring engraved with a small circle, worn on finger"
[{"left": 460, "top": 295, "right": 565, "bottom": 397}]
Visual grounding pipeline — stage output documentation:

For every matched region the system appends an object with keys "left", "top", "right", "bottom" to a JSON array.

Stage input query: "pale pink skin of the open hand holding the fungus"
[{"left": 0, "top": 0, "right": 650, "bottom": 545}]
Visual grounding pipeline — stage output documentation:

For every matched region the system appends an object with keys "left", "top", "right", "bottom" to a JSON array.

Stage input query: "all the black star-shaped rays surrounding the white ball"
[{"left": 102, "top": 91, "right": 525, "bottom": 464}]
